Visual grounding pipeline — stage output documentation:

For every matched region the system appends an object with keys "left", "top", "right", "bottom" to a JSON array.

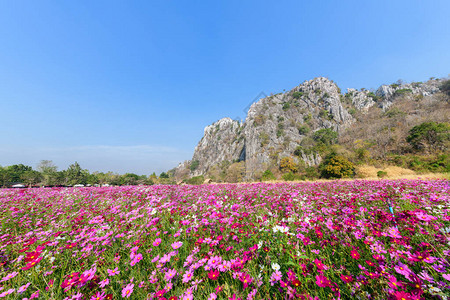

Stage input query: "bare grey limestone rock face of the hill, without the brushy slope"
[{"left": 175, "top": 77, "right": 441, "bottom": 180}]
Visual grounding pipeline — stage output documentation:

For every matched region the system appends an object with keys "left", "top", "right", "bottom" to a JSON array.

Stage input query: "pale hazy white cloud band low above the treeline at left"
[{"left": 0, "top": 145, "right": 192, "bottom": 175}]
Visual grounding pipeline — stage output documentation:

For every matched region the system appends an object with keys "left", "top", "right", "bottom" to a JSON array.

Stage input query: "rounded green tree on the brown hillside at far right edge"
[{"left": 406, "top": 122, "right": 450, "bottom": 152}]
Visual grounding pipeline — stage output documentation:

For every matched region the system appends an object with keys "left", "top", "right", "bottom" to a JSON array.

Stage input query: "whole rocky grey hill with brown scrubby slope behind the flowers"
[{"left": 171, "top": 77, "right": 450, "bottom": 181}]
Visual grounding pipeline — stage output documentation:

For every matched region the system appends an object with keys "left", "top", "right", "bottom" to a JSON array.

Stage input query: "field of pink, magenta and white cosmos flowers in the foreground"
[{"left": 0, "top": 180, "right": 450, "bottom": 300}]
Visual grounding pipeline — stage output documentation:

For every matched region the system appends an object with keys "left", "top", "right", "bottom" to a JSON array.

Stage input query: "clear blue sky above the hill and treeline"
[{"left": 0, "top": 0, "right": 450, "bottom": 175}]
